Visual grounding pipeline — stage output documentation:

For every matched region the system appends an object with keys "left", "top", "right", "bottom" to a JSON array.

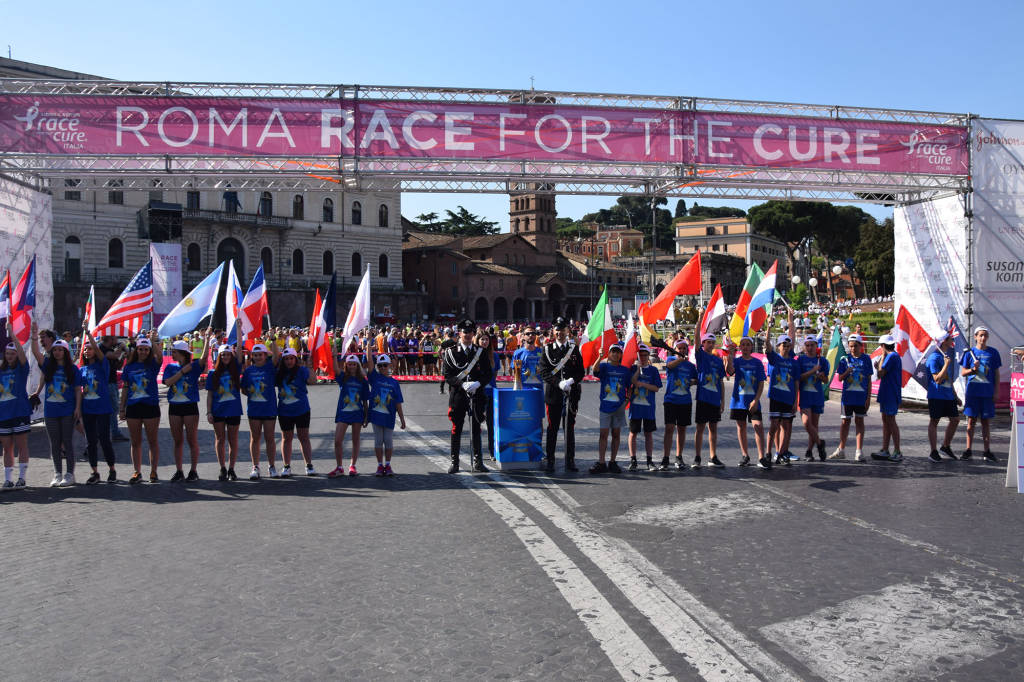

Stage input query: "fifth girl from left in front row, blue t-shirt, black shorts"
[{"left": 164, "top": 328, "right": 213, "bottom": 482}]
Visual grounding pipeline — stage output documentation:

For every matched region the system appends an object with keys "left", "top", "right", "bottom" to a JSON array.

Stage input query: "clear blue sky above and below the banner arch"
[{"left": 0, "top": 0, "right": 1024, "bottom": 229}]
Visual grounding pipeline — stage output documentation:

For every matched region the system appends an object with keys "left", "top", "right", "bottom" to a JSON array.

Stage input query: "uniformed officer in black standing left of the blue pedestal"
[{"left": 441, "top": 319, "right": 493, "bottom": 473}]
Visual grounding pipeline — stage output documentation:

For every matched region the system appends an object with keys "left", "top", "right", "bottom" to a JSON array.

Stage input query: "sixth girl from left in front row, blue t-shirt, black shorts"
[{"left": 206, "top": 337, "right": 243, "bottom": 480}]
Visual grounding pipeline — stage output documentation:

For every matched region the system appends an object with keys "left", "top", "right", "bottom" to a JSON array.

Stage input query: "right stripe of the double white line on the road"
[{"left": 406, "top": 419, "right": 799, "bottom": 680}]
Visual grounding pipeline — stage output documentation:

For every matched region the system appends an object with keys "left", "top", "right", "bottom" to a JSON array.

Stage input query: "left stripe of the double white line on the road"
[{"left": 397, "top": 418, "right": 675, "bottom": 680}]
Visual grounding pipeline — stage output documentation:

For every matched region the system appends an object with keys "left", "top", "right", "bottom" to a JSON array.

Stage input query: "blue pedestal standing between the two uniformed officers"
[{"left": 492, "top": 388, "right": 544, "bottom": 469}]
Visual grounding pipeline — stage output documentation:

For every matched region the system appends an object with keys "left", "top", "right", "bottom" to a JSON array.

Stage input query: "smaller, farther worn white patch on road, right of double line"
[{"left": 615, "top": 493, "right": 782, "bottom": 528}]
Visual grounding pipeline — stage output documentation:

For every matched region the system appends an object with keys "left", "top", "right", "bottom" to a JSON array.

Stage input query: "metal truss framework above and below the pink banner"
[{"left": 0, "top": 79, "right": 972, "bottom": 204}]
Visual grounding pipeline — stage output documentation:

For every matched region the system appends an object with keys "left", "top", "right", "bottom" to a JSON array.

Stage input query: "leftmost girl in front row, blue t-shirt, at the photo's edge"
[{"left": 0, "top": 317, "right": 32, "bottom": 492}]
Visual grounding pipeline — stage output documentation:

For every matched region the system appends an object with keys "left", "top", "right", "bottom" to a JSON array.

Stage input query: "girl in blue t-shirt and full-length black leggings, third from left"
[{"left": 75, "top": 329, "right": 115, "bottom": 483}]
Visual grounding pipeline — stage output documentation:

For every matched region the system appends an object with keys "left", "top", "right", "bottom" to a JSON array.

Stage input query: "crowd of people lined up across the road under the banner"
[{"left": 0, "top": 301, "right": 1001, "bottom": 492}]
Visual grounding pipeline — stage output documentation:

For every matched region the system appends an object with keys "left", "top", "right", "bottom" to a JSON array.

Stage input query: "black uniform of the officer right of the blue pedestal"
[{"left": 537, "top": 333, "right": 587, "bottom": 471}]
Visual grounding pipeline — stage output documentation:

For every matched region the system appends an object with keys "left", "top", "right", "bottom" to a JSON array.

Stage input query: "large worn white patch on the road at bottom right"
[{"left": 761, "top": 574, "right": 1024, "bottom": 681}]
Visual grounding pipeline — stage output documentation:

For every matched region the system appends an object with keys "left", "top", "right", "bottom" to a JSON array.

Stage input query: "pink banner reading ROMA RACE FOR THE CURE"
[{"left": 0, "top": 95, "right": 968, "bottom": 175}]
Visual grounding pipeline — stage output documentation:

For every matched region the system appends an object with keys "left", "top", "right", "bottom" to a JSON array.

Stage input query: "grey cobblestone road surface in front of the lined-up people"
[{"left": 0, "top": 384, "right": 1024, "bottom": 680}]
